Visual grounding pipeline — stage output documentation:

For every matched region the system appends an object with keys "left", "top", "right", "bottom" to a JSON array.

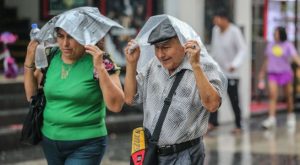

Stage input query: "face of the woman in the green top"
[{"left": 57, "top": 28, "right": 85, "bottom": 59}]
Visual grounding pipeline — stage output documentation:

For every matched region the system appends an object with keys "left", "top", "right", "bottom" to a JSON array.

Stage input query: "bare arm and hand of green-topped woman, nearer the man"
[{"left": 85, "top": 45, "right": 124, "bottom": 112}]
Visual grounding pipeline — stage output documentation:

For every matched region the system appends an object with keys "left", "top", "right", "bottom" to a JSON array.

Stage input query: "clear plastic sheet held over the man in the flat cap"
[{"left": 135, "top": 14, "right": 227, "bottom": 95}]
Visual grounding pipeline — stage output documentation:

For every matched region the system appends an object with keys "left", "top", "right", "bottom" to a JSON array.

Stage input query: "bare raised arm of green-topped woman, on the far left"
[{"left": 24, "top": 41, "right": 40, "bottom": 101}]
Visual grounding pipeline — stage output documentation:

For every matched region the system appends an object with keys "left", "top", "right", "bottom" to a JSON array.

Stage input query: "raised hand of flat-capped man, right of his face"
[{"left": 184, "top": 40, "right": 201, "bottom": 66}]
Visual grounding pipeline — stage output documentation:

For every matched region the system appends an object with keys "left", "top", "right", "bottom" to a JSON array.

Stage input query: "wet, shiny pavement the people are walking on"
[{"left": 0, "top": 113, "right": 300, "bottom": 165}]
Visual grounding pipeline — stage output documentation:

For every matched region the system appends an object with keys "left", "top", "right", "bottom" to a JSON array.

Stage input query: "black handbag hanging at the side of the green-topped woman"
[{"left": 20, "top": 88, "right": 46, "bottom": 145}]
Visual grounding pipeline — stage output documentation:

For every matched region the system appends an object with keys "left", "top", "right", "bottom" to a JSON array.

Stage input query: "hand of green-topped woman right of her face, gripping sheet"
[{"left": 85, "top": 45, "right": 105, "bottom": 71}]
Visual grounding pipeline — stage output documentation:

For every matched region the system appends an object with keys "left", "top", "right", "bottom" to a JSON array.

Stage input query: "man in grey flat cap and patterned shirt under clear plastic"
[{"left": 124, "top": 15, "right": 226, "bottom": 165}]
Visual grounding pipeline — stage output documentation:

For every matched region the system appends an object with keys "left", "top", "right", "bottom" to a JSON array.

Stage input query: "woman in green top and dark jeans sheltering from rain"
[{"left": 24, "top": 13, "right": 124, "bottom": 165}]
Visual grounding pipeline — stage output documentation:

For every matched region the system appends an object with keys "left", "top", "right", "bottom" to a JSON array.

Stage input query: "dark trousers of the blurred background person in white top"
[{"left": 209, "top": 79, "right": 241, "bottom": 128}]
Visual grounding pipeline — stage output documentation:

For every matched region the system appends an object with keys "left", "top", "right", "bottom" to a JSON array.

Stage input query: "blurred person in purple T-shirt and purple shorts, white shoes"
[{"left": 259, "top": 27, "right": 300, "bottom": 129}]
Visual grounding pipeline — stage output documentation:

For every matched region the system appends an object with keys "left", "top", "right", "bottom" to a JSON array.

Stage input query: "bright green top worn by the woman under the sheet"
[{"left": 42, "top": 51, "right": 107, "bottom": 140}]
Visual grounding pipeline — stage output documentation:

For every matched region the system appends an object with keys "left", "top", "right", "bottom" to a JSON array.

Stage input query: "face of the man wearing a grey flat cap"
[{"left": 154, "top": 37, "right": 185, "bottom": 73}]
